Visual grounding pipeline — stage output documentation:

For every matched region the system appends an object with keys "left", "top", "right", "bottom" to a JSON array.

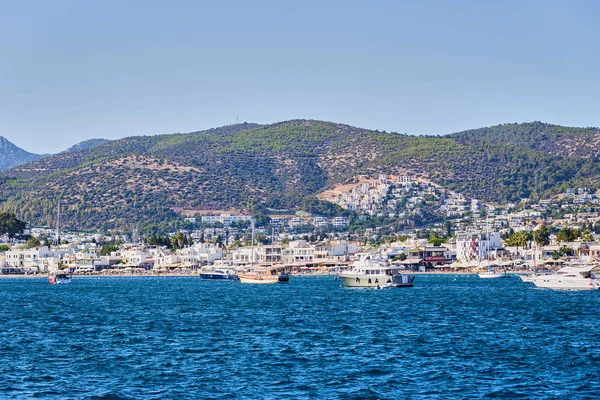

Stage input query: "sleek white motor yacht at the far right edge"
[{"left": 528, "top": 265, "right": 600, "bottom": 290}]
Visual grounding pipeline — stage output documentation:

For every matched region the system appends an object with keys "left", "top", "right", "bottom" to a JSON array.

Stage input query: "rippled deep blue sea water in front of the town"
[{"left": 0, "top": 276, "right": 600, "bottom": 399}]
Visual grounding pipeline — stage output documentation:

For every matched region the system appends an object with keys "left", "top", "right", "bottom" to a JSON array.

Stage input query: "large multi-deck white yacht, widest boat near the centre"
[{"left": 338, "top": 255, "right": 415, "bottom": 289}]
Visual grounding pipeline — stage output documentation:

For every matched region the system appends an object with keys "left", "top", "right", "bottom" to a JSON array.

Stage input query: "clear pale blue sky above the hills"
[{"left": 0, "top": 0, "right": 600, "bottom": 153}]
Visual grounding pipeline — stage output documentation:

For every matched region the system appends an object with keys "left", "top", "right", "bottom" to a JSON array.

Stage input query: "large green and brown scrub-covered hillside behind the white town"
[{"left": 0, "top": 120, "right": 600, "bottom": 229}]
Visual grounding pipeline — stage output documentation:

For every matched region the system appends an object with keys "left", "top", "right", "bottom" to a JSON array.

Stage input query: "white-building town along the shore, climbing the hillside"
[{"left": 0, "top": 174, "right": 600, "bottom": 275}]
